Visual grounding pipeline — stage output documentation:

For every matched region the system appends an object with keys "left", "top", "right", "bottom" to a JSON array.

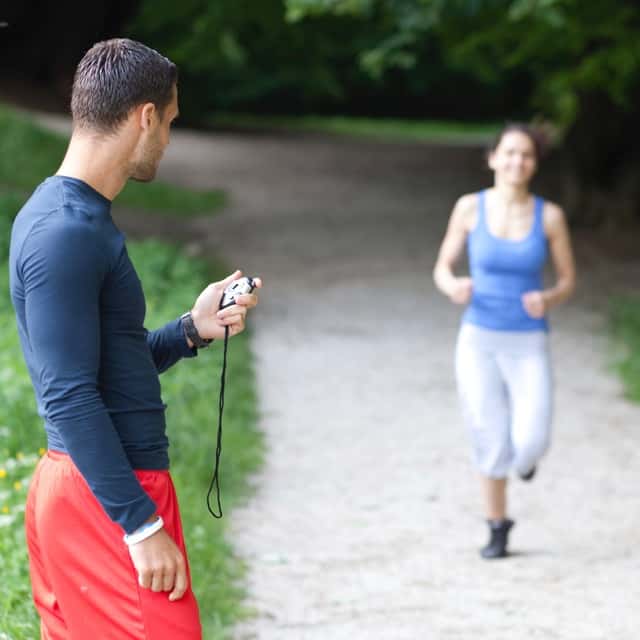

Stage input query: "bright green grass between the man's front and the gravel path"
[{"left": 130, "top": 241, "right": 262, "bottom": 638}]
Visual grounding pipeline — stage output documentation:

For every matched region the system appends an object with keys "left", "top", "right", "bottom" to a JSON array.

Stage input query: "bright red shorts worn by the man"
[{"left": 25, "top": 451, "right": 202, "bottom": 640}]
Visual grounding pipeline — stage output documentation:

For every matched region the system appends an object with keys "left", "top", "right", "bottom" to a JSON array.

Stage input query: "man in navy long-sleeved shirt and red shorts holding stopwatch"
[{"left": 10, "top": 39, "right": 261, "bottom": 640}]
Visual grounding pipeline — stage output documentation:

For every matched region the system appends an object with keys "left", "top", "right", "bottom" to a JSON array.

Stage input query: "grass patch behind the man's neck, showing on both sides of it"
[{"left": 0, "top": 105, "right": 225, "bottom": 216}]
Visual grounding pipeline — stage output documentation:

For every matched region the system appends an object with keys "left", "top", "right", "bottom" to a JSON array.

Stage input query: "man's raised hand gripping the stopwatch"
[{"left": 191, "top": 271, "right": 262, "bottom": 339}]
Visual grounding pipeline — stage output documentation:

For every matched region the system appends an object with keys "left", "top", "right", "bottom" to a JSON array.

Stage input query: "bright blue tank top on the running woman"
[{"left": 462, "top": 191, "right": 549, "bottom": 331}]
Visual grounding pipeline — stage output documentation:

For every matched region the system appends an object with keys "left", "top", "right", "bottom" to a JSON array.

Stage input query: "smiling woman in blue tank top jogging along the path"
[{"left": 434, "top": 124, "right": 575, "bottom": 559}]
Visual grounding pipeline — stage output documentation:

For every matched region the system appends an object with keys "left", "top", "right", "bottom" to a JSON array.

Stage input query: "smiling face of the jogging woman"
[{"left": 489, "top": 131, "right": 538, "bottom": 186}]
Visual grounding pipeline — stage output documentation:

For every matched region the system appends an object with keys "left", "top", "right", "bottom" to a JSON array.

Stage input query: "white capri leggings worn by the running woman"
[{"left": 456, "top": 323, "right": 553, "bottom": 478}]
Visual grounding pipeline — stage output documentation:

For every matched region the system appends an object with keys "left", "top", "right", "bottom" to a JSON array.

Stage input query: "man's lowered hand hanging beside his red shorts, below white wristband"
[{"left": 129, "top": 529, "right": 189, "bottom": 602}]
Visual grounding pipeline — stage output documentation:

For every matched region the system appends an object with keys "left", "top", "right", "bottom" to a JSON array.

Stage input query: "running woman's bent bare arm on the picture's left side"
[{"left": 433, "top": 194, "right": 476, "bottom": 304}]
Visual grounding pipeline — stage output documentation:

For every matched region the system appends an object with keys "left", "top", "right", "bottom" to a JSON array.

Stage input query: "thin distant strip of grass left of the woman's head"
[{"left": 207, "top": 113, "right": 501, "bottom": 143}]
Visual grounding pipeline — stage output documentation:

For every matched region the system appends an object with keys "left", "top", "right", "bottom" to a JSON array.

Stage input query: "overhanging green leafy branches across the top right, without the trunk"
[{"left": 287, "top": 0, "right": 640, "bottom": 125}]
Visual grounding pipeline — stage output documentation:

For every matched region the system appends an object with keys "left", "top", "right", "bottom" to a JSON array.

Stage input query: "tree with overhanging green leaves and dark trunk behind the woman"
[{"left": 287, "top": 0, "right": 640, "bottom": 223}]
